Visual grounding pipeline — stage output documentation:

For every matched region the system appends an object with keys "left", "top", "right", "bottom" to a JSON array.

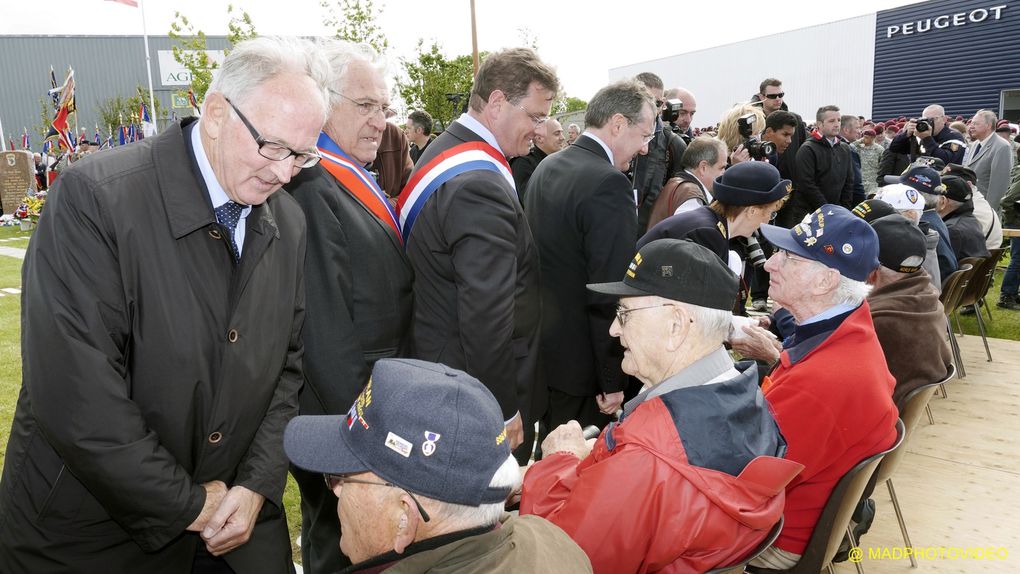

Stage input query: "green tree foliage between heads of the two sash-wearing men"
[{"left": 397, "top": 40, "right": 486, "bottom": 126}]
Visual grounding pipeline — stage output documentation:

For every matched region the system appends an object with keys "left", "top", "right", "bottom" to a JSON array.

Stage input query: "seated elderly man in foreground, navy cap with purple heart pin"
[{"left": 284, "top": 359, "right": 592, "bottom": 574}]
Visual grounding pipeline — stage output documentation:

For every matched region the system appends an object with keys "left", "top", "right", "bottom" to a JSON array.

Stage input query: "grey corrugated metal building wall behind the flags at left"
[{"left": 0, "top": 36, "right": 230, "bottom": 151}]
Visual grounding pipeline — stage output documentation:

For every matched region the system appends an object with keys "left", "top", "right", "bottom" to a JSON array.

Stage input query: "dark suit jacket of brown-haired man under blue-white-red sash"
[{"left": 406, "top": 122, "right": 541, "bottom": 424}]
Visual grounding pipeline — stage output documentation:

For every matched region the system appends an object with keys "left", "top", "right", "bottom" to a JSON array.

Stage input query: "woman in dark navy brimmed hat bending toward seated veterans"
[{"left": 638, "top": 161, "right": 792, "bottom": 275}]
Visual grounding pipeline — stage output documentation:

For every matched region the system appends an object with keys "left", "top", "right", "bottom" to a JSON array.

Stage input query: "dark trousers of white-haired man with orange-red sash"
[{"left": 291, "top": 466, "right": 351, "bottom": 574}]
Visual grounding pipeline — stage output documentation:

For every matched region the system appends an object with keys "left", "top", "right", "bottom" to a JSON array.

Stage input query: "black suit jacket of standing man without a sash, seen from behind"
[{"left": 524, "top": 136, "right": 638, "bottom": 397}]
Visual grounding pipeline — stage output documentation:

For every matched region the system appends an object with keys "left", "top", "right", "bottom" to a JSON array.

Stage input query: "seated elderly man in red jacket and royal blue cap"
[{"left": 751, "top": 204, "right": 898, "bottom": 569}]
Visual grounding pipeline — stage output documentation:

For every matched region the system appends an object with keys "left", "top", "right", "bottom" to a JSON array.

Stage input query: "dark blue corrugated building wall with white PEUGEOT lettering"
[{"left": 872, "top": 0, "right": 1020, "bottom": 119}]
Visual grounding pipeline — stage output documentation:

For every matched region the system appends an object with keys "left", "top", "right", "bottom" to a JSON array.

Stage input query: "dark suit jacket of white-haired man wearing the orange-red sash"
[{"left": 286, "top": 165, "right": 413, "bottom": 418}]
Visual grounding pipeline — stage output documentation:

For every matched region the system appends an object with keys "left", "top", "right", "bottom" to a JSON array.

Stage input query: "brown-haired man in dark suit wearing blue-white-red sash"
[{"left": 398, "top": 48, "right": 559, "bottom": 458}]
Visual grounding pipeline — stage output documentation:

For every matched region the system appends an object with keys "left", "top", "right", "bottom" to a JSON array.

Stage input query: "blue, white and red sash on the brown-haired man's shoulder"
[{"left": 397, "top": 142, "right": 517, "bottom": 238}]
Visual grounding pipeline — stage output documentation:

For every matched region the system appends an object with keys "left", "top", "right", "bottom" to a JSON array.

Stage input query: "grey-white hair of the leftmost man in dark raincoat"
[{"left": 207, "top": 36, "right": 329, "bottom": 121}]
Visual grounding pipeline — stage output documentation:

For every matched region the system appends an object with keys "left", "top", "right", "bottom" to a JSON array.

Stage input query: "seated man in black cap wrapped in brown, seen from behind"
[{"left": 868, "top": 214, "right": 953, "bottom": 412}]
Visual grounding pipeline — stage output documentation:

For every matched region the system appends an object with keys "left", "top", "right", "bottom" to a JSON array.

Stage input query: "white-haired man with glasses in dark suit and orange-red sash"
[{"left": 287, "top": 41, "right": 412, "bottom": 574}]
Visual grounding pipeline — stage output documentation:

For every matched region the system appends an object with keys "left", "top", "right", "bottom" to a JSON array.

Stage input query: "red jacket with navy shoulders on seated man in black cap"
[{"left": 520, "top": 369, "right": 801, "bottom": 574}]
